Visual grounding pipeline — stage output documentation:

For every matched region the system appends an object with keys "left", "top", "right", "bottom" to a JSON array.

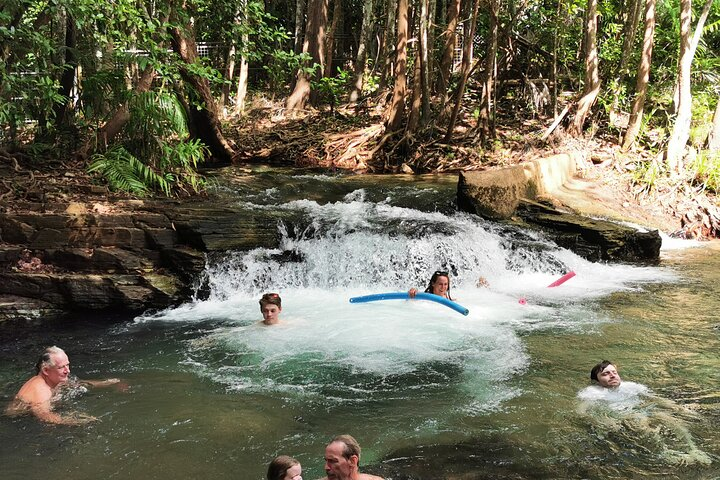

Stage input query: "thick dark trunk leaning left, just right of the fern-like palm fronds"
[{"left": 171, "top": 23, "right": 234, "bottom": 165}]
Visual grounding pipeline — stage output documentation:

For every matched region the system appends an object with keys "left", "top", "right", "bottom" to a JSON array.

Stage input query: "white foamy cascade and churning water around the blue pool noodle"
[{"left": 137, "top": 182, "right": 688, "bottom": 411}]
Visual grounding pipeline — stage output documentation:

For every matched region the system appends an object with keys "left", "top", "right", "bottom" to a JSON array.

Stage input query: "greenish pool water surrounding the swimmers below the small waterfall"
[{"left": 0, "top": 171, "right": 720, "bottom": 480}]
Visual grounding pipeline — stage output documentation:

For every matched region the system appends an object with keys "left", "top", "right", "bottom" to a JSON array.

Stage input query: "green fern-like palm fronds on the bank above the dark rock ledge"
[{"left": 88, "top": 91, "right": 208, "bottom": 196}]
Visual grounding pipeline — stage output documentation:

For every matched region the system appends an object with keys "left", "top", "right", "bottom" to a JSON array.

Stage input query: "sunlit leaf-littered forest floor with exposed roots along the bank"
[{"left": 0, "top": 97, "right": 717, "bottom": 238}]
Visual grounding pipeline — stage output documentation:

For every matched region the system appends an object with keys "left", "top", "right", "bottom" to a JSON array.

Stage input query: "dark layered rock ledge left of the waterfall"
[{"left": 0, "top": 201, "right": 278, "bottom": 321}]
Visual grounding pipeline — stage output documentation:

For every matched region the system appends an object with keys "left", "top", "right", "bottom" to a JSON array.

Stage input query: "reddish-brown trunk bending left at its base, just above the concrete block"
[{"left": 572, "top": 0, "right": 600, "bottom": 136}]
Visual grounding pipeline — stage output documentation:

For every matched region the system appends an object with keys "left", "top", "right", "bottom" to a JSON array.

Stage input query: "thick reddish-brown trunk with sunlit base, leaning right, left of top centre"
[{"left": 285, "top": 0, "right": 328, "bottom": 110}]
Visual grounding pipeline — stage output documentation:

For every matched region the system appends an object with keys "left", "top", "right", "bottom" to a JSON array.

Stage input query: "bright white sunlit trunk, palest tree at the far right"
[{"left": 667, "top": 0, "right": 692, "bottom": 174}]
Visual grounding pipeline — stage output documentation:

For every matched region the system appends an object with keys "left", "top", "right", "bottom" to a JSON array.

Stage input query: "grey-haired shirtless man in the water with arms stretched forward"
[{"left": 6, "top": 347, "right": 120, "bottom": 425}]
